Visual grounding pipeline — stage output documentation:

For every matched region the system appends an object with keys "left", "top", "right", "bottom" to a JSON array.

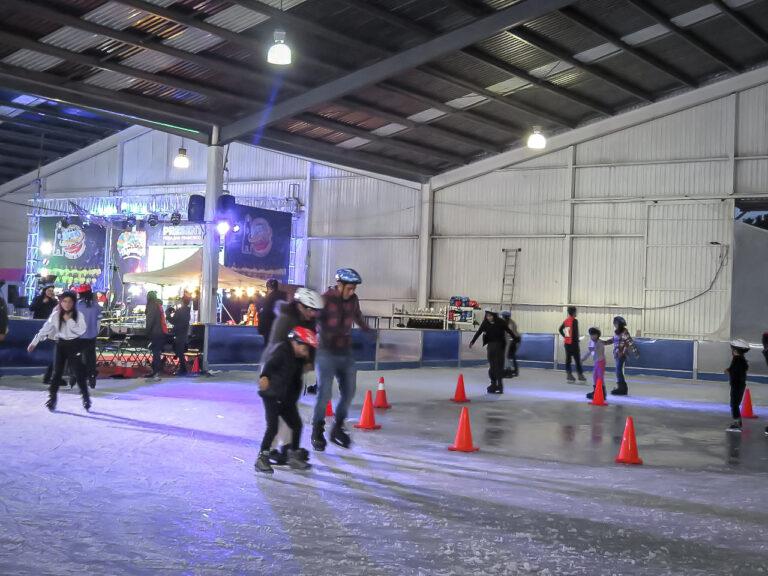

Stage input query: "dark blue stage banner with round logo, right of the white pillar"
[{"left": 224, "top": 204, "right": 293, "bottom": 283}]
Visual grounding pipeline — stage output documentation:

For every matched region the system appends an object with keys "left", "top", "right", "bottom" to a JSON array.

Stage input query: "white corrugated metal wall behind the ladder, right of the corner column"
[{"left": 431, "top": 86, "right": 768, "bottom": 338}]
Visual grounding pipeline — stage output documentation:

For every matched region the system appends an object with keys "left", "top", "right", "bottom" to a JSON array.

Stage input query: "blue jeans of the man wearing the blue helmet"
[{"left": 312, "top": 349, "right": 357, "bottom": 424}]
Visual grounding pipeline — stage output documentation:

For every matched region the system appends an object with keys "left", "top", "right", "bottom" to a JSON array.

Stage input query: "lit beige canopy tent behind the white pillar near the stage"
[{"left": 123, "top": 248, "right": 267, "bottom": 291}]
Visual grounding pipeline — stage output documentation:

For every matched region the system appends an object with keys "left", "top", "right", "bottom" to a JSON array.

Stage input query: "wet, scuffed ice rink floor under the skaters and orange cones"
[{"left": 0, "top": 369, "right": 768, "bottom": 576}]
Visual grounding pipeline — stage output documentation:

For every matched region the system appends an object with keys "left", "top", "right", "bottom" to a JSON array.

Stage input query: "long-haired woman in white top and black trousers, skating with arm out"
[{"left": 27, "top": 292, "right": 91, "bottom": 412}]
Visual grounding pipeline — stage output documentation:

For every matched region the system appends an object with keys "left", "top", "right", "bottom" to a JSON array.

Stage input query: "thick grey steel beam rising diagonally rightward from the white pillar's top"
[{"left": 222, "top": 0, "right": 574, "bottom": 141}]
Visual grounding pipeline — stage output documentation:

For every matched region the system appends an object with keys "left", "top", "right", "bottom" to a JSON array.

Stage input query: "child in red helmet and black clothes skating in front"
[{"left": 255, "top": 326, "right": 317, "bottom": 474}]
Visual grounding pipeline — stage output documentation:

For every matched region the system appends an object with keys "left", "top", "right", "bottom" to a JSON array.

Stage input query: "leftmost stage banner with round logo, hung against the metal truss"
[{"left": 39, "top": 216, "right": 107, "bottom": 291}]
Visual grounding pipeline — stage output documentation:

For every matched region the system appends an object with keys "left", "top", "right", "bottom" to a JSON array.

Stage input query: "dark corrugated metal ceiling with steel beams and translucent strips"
[{"left": 0, "top": 0, "right": 768, "bottom": 182}]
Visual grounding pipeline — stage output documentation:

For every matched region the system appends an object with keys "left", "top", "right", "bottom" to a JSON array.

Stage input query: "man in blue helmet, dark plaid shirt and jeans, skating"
[{"left": 312, "top": 268, "right": 370, "bottom": 451}]
